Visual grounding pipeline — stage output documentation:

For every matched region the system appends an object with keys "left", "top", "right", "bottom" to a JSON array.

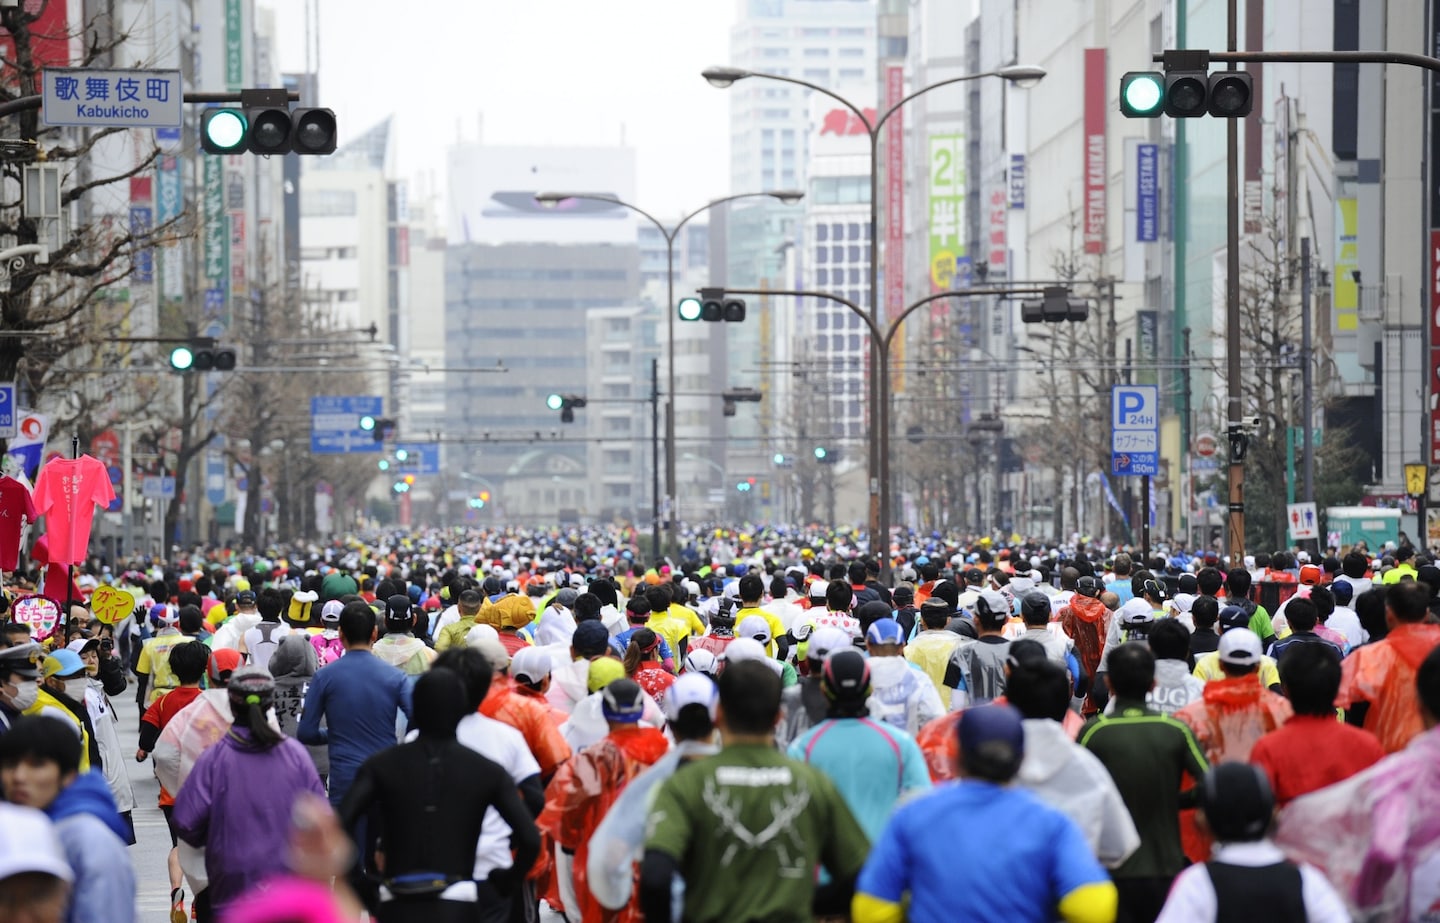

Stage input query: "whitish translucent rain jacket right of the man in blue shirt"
[{"left": 1015, "top": 719, "right": 1140, "bottom": 868}]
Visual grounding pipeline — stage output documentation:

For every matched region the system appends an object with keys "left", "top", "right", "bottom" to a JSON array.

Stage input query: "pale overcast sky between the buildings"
[{"left": 269, "top": 0, "right": 736, "bottom": 227}]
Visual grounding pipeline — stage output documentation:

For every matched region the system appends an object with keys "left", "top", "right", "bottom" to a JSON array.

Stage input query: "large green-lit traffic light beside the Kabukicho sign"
[{"left": 200, "top": 89, "right": 338, "bottom": 156}]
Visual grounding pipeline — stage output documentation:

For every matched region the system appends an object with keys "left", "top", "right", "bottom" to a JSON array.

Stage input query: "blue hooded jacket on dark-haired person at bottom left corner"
[{"left": 45, "top": 772, "right": 137, "bottom": 923}]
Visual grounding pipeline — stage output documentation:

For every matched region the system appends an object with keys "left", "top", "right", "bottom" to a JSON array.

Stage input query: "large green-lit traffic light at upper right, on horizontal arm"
[{"left": 1120, "top": 61, "right": 1254, "bottom": 118}]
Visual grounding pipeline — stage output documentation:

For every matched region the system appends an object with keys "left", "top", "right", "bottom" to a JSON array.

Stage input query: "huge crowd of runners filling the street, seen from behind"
[{"left": 0, "top": 530, "right": 1440, "bottom": 923}]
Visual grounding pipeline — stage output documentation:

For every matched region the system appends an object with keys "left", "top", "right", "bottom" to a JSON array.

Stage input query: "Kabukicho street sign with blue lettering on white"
[{"left": 40, "top": 68, "right": 184, "bottom": 128}]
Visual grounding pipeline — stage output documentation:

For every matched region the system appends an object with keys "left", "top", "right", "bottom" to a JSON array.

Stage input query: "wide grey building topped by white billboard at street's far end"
[{"left": 445, "top": 144, "right": 639, "bottom": 523}]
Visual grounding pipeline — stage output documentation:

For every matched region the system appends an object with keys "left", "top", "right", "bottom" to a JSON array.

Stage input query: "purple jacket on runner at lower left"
[{"left": 174, "top": 727, "right": 325, "bottom": 909}]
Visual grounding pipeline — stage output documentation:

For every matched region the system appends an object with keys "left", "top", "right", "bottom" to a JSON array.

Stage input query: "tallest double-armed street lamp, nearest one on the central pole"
[{"left": 700, "top": 65, "right": 1045, "bottom": 561}]
